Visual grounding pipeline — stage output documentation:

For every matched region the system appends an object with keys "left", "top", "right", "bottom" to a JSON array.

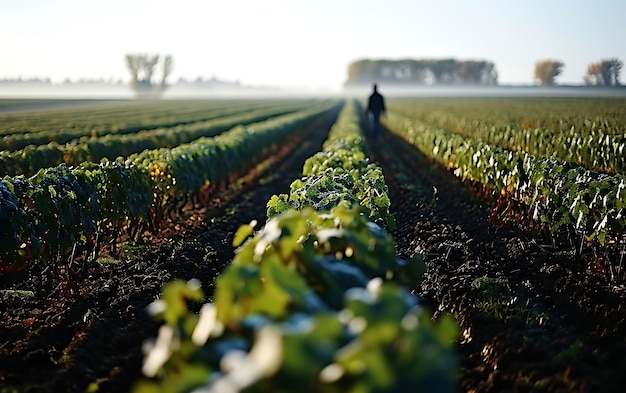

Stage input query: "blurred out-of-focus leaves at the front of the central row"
[{"left": 135, "top": 206, "right": 459, "bottom": 393}]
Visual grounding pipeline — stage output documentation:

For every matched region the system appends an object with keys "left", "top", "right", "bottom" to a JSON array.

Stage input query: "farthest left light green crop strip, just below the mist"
[{"left": 0, "top": 100, "right": 298, "bottom": 151}]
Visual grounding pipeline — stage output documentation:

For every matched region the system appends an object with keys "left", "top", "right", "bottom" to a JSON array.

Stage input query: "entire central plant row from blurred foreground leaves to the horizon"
[{"left": 133, "top": 102, "right": 458, "bottom": 393}]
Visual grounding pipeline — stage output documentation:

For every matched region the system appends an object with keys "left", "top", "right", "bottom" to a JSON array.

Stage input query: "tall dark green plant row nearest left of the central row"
[{"left": 0, "top": 102, "right": 339, "bottom": 274}]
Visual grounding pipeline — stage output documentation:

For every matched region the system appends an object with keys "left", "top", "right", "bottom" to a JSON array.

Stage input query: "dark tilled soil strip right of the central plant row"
[{"left": 370, "top": 125, "right": 626, "bottom": 392}]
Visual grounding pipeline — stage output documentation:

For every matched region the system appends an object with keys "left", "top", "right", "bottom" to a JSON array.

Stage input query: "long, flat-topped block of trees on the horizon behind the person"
[{"left": 346, "top": 59, "right": 498, "bottom": 86}]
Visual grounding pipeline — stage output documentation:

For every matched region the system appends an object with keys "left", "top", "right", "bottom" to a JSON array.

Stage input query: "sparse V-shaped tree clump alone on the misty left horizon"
[{"left": 126, "top": 53, "right": 174, "bottom": 96}]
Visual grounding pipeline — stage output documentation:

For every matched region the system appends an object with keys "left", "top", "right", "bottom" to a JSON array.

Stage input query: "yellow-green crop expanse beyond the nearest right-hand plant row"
[{"left": 393, "top": 98, "right": 626, "bottom": 175}]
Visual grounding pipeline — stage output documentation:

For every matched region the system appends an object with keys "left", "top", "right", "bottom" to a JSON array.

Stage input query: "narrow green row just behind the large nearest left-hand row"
[{"left": 0, "top": 102, "right": 316, "bottom": 176}]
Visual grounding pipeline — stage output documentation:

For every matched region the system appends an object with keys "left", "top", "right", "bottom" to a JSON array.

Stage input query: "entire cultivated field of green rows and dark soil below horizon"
[{"left": 0, "top": 97, "right": 626, "bottom": 393}]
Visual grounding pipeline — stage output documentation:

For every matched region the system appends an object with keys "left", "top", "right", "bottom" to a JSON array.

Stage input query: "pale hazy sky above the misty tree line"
[{"left": 0, "top": 0, "right": 626, "bottom": 89}]
